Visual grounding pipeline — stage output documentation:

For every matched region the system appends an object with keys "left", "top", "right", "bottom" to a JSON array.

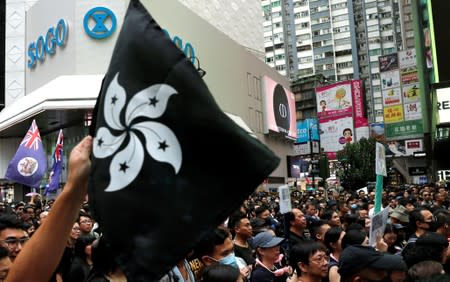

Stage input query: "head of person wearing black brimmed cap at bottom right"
[{"left": 338, "top": 245, "right": 406, "bottom": 282}]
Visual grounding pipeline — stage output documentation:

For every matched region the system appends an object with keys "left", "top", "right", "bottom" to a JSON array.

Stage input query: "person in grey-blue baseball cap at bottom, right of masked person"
[{"left": 250, "top": 231, "right": 291, "bottom": 282}]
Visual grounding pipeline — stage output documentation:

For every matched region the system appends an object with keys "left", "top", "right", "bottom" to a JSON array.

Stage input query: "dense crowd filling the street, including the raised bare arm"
[{"left": 0, "top": 137, "right": 450, "bottom": 282}]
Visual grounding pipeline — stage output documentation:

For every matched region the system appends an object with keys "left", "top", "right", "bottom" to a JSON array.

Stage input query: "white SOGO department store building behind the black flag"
[{"left": 0, "top": 0, "right": 295, "bottom": 200}]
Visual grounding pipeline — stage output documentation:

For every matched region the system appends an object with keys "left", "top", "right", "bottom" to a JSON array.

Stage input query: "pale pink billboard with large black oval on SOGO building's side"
[{"left": 263, "top": 76, "right": 297, "bottom": 140}]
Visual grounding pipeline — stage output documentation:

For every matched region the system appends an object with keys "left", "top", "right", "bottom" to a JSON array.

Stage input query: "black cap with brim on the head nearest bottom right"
[{"left": 338, "top": 246, "right": 406, "bottom": 279}]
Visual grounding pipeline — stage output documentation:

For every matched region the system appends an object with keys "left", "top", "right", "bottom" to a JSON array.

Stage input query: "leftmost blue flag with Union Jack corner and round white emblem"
[{"left": 5, "top": 120, "right": 47, "bottom": 188}]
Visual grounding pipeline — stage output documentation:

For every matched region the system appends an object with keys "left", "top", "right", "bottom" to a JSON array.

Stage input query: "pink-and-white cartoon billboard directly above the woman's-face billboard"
[{"left": 316, "top": 81, "right": 353, "bottom": 119}]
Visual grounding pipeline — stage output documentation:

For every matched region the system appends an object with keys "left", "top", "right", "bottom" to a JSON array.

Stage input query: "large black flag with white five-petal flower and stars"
[{"left": 89, "top": 0, "right": 279, "bottom": 281}]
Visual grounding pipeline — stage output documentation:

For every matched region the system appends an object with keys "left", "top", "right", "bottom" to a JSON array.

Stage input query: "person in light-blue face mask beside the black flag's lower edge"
[{"left": 194, "top": 227, "right": 250, "bottom": 278}]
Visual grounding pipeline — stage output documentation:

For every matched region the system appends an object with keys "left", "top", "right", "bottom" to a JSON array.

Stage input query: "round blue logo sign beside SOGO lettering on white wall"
[{"left": 83, "top": 7, "right": 117, "bottom": 39}]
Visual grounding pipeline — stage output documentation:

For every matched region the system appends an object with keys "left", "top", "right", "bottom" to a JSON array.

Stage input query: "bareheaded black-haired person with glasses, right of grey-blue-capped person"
[{"left": 289, "top": 241, "right": 329, "bottom": 282}]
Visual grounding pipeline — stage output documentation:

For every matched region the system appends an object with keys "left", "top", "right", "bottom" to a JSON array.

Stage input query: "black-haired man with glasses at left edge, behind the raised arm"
[{"left": 0, "top": 214, "right": 30, "bottom": 262}]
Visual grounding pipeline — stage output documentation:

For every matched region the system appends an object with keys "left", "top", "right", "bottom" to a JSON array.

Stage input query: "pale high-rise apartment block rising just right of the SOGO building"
[{"left": 261, "top": 0, "right": 358, "bottom": 80}]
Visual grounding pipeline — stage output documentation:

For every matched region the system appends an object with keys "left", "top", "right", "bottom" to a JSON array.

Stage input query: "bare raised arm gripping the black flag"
[{"left": 6, "top": 136, "right": 92, "bottom": 281}]
